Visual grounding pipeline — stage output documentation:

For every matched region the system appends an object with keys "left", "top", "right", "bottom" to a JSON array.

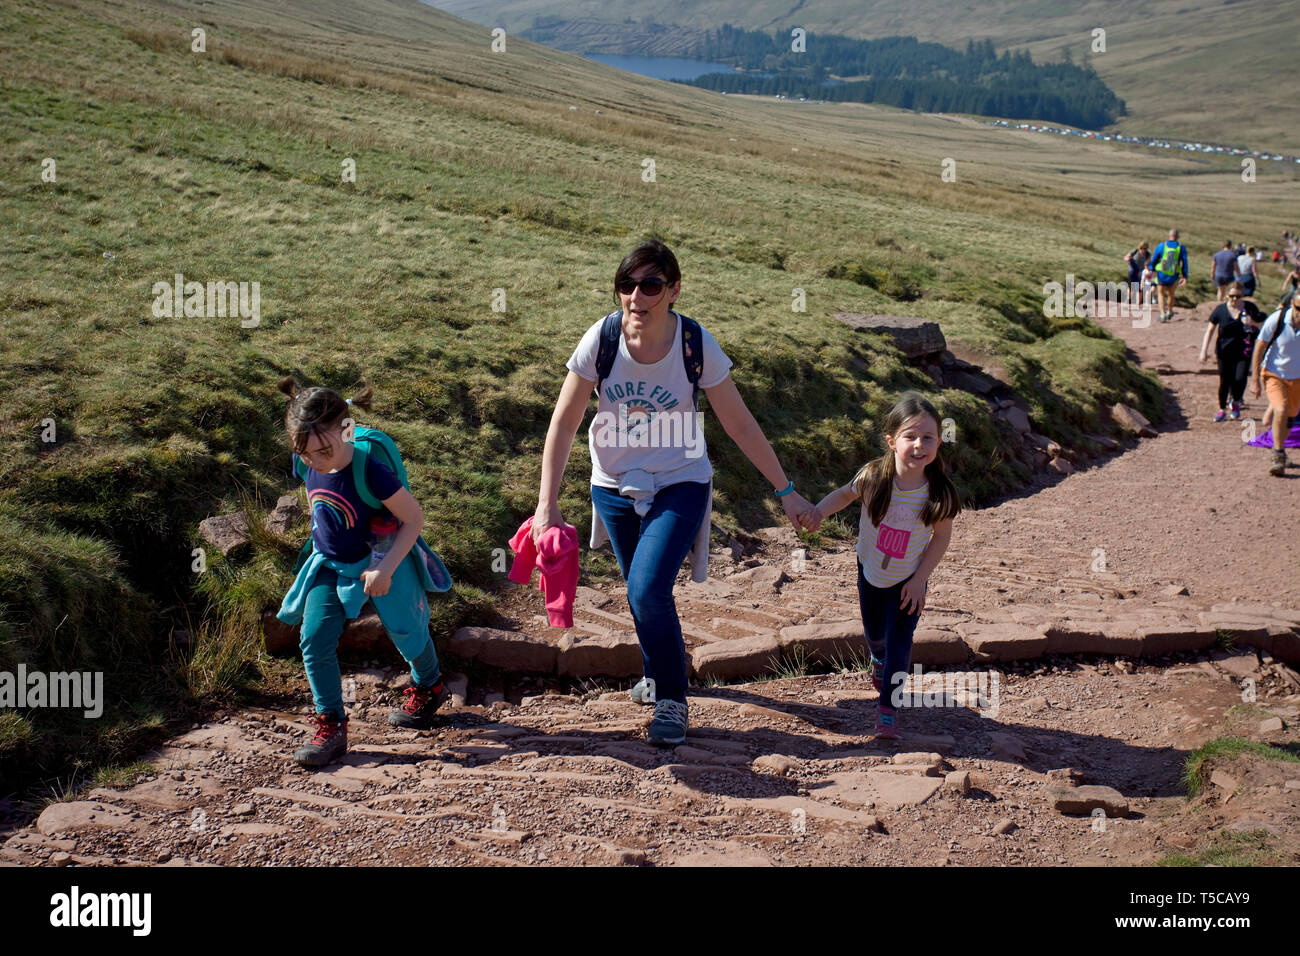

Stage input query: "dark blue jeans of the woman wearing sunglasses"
[{"left": 592, "top": 481, "right": 709, "bottom": 704}]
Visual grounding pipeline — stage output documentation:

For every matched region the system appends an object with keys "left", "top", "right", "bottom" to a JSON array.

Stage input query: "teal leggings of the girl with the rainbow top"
[{"left": 299, "top": 561, "right": 441, "bottom": 721}]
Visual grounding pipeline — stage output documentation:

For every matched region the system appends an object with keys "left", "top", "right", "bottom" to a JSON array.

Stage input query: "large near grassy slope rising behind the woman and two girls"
[{"left": 0, "top": 0, "right": 1295, "bottom": 792}]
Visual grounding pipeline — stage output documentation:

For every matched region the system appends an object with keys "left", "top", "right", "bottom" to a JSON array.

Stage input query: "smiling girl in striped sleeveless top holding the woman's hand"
[{"left": 805, "top": 392, "right": 961, "bottom": 739}]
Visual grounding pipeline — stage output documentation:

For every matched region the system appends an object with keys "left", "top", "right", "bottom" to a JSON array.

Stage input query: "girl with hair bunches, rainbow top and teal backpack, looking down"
[{"left": 276, "top": 376, "right": 451, "bottom": 767}]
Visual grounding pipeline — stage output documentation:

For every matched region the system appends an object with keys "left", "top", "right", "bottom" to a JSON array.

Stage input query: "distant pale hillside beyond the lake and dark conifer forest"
[{"left": 434, "top": 0, "right": 1300, "bottom": 152}]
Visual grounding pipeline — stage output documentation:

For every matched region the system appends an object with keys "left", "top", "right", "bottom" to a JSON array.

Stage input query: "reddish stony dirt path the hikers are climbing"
[{"left": 0, "top": 308, "right": 1300, "bottom": 865}]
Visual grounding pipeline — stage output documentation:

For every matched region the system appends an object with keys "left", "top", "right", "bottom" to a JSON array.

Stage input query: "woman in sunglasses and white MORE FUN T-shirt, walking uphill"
[{"left": 532, "top": 241, "right": 811, "bottom": 745}]
